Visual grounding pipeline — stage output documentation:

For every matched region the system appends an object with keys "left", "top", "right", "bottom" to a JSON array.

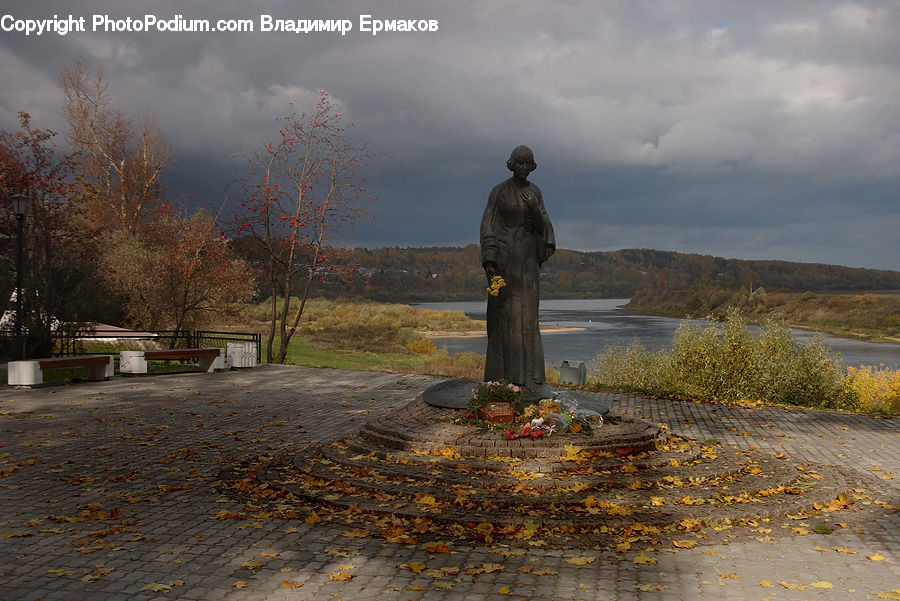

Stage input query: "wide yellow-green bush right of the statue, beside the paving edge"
[{"left": 589, "top": 311, "right": 860, "bottom": 409}]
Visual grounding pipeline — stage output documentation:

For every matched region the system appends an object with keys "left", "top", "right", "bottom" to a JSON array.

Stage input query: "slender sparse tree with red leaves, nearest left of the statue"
[{"left": 234, "top": 92, "right": 380, "bottom": 363}]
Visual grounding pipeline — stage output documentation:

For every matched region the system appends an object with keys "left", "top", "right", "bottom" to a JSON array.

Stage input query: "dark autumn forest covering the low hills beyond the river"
[{"left": 241, "top": 244, "right": 900, "bottom": 303}]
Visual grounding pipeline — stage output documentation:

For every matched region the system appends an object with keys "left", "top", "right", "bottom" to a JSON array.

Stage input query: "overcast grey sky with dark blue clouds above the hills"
[{"left": 0, "top": 0, "right": 900, "bottom": 269}]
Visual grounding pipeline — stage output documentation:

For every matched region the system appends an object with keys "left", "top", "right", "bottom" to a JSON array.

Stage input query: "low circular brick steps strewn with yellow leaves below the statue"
[{"left": 246, "top": 397, "right": 864, "bottom": 545}]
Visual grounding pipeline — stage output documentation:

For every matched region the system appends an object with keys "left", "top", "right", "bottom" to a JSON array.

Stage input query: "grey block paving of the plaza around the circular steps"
[{"left": 0, "top": 366, "right": 900, "bottom": 601}]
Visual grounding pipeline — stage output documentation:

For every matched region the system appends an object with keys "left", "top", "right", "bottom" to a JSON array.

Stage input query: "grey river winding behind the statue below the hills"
[{"left": 416, "top": 299, "right": 900, "bottom": 369}]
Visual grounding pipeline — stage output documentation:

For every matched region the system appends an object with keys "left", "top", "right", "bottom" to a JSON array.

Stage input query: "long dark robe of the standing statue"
[{"left": 481, "top": 178, "right": 556, "bottom": 391}]
